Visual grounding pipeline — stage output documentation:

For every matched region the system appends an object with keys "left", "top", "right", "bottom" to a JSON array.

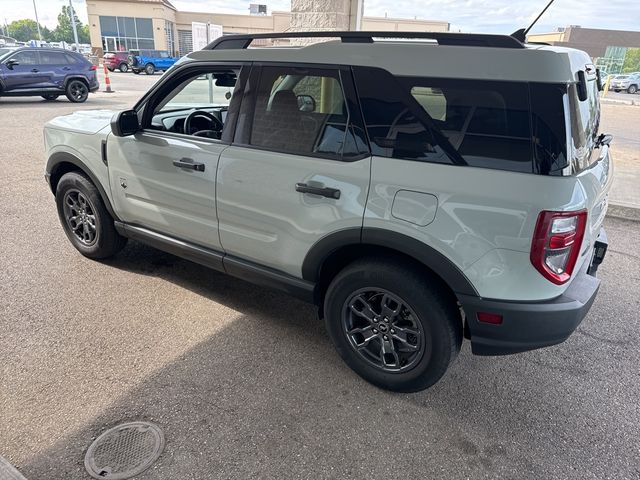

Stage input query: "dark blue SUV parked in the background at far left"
[{"left": 0, "top": 47, "right": 100, "bottom": 103}]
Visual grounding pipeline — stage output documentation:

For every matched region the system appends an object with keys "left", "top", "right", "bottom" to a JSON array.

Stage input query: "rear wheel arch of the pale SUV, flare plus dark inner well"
[{"left": 302, "top": 228, "right": 478, "bottom": 309}]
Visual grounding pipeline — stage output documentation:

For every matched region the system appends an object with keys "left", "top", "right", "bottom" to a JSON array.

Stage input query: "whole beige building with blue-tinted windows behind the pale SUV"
[{"left": 87, "top": 0, "right": 449, "bottom": 56}]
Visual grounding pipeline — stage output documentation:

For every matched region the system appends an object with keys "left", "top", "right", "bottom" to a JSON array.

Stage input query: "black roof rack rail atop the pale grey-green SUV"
[{"left": 204, "top": 31, "right": 524, "bottom": 50}]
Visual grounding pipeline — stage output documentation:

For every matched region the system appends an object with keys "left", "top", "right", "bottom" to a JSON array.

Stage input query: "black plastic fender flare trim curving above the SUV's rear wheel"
[{"left": 302, "top": 227, "right": 478, "bottom": 297}]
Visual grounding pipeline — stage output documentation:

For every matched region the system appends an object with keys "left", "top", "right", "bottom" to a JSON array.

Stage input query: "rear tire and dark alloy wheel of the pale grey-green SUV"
[{"left": 324, "top": 258, "right": 462, "bottom": 392}]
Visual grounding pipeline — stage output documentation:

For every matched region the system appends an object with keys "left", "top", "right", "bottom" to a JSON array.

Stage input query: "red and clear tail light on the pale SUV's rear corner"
[{"left": 531, "top": 210, "right": 587, "bottom": 285}]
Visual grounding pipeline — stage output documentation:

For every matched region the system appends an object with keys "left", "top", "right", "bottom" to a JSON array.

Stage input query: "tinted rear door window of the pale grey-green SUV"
[{"left": 249, "top": 67, "right": 366, "bottom": 158}]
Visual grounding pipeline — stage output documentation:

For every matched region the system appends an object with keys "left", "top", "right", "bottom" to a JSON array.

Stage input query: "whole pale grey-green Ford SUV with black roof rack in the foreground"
[{"left": 45, "top": 32, "right": 612, "bottom": 391}]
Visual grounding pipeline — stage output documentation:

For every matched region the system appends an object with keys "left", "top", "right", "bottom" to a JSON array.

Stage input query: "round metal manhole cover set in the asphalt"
[{"left": 84, "top": 422, "right": 164, "bottom": 480}]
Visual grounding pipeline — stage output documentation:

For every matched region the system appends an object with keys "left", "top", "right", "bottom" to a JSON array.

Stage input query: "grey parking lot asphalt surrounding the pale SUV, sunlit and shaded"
[{"left": 0, "top": 73, "right": 640, "bottom": 479}]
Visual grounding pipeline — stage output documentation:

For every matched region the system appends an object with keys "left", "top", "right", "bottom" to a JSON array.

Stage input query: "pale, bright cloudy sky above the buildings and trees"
[{"left": 5, "top": 0, "right": 640, "bottom": 33}]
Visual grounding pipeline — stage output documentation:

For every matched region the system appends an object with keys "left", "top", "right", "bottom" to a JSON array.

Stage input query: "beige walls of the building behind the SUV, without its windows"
[{"left": 87, "top": 0, "right": 449, "bottom": 56}]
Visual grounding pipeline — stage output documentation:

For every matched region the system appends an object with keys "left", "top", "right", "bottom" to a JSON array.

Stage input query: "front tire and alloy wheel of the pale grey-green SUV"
[{"left": 56, "top": 172, "right": 127, "bottom": 259}]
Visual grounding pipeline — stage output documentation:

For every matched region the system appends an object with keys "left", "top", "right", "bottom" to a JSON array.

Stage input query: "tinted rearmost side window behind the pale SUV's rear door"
[{"left": 355, "top": 68, "right": 533, "bottom": 172}]
